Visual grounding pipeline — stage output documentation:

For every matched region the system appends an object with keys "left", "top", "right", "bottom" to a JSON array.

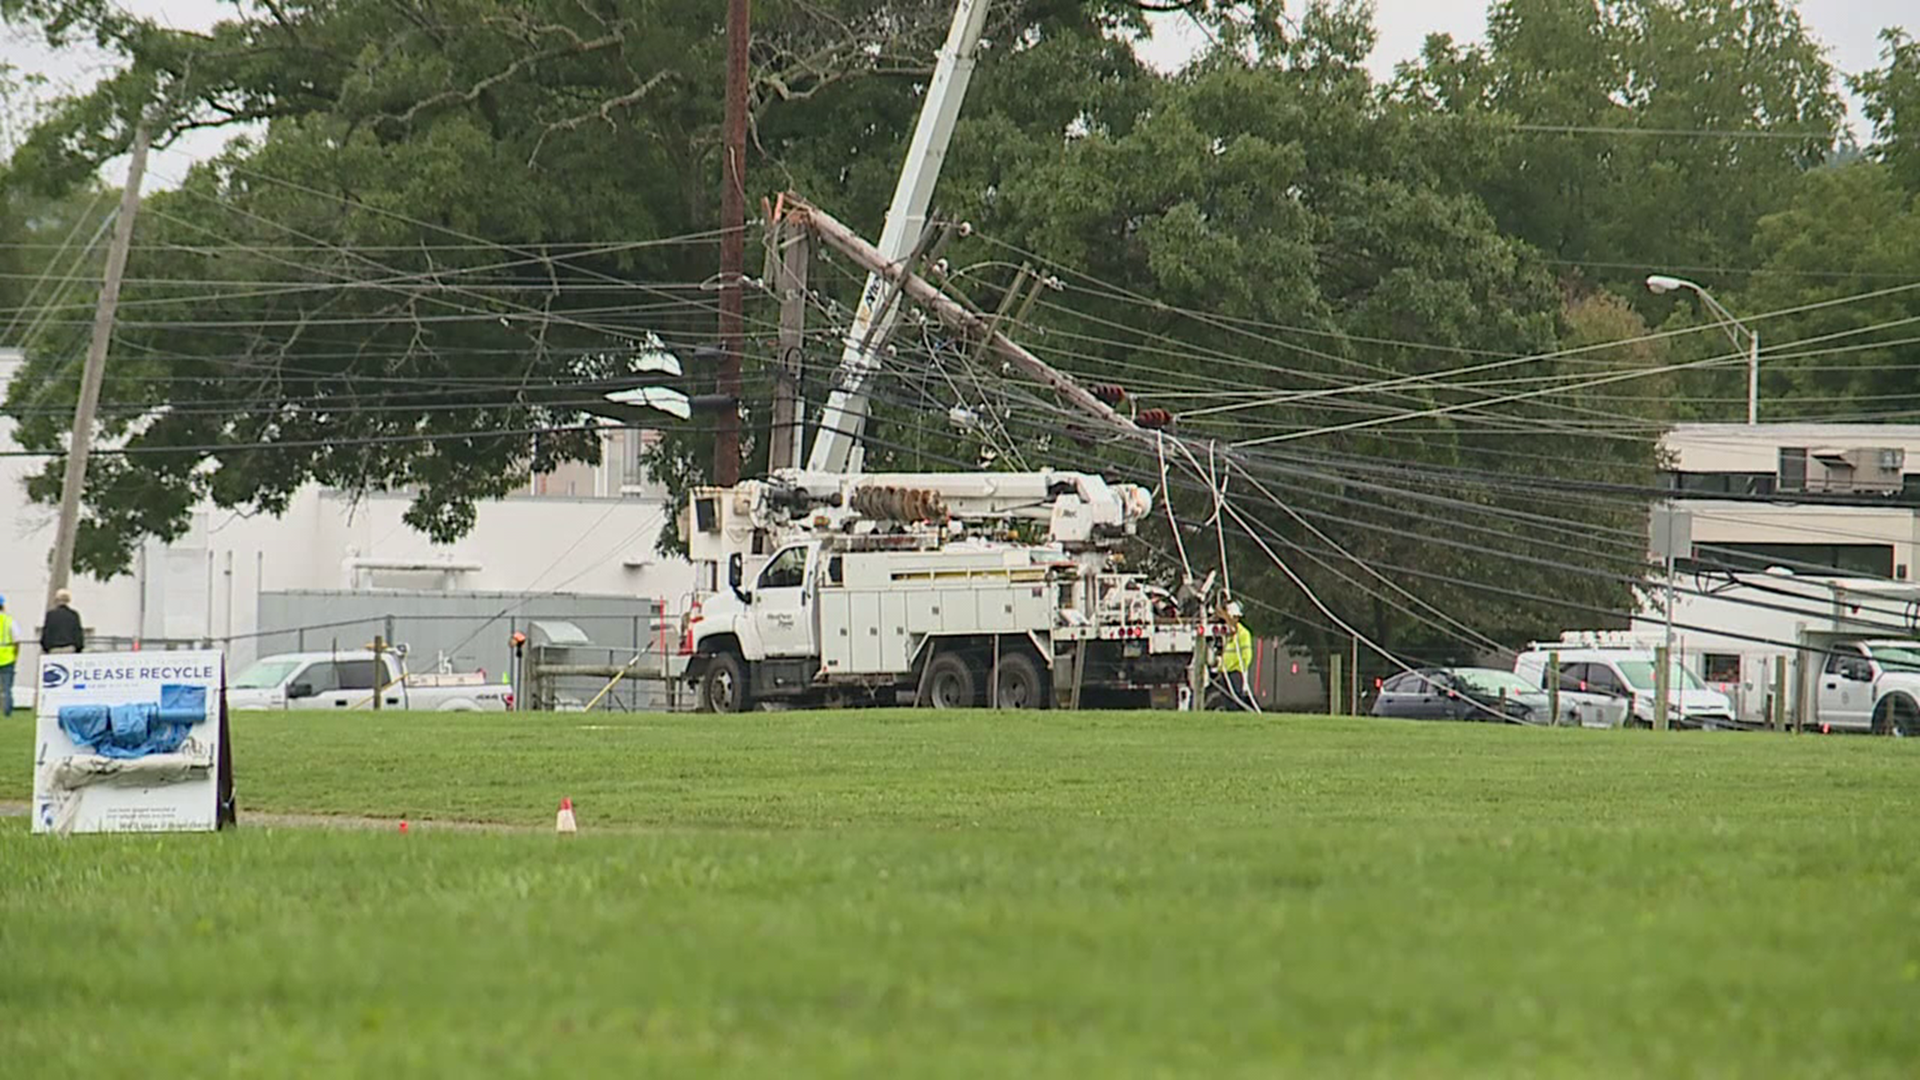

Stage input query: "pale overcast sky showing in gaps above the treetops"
[{"left": 0, "top": 0, "right": 1920, "bottom": 188}]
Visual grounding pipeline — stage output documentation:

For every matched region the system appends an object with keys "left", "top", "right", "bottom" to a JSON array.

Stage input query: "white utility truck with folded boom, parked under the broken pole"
[{"left": 687, "top": 471, "right": 1208, "bottom": 711}]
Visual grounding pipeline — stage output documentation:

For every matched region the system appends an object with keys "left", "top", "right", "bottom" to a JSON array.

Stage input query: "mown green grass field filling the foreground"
[{"left": 0, "top": 713, "right": 1920, "bottom": 1078}]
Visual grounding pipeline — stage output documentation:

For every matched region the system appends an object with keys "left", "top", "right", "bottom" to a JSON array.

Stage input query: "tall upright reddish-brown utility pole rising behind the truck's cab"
[{"left": 714, "top": 0, "right": 751, "bottom": 486}]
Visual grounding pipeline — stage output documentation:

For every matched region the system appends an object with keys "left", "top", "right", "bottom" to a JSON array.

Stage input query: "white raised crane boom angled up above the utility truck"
[{"left": 806, "top": 0, "right": 989, "bottom": 473}]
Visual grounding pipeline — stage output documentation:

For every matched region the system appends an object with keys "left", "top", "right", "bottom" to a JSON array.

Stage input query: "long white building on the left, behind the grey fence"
[{"left": 0, "top": 350, "right": 693, "bottom": 671}]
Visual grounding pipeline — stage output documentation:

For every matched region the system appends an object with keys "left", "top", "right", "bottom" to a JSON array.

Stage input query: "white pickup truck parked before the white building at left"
[{"left": 227, "top": 650, "right": 513, "bottom": 713}]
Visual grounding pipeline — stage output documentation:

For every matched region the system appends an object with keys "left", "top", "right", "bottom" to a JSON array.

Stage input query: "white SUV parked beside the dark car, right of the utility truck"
[{"left": 1513, "top": 642, "right": 1740, "bottom": 728}]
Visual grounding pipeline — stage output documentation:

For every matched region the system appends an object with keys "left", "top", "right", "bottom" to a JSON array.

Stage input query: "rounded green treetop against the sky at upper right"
[{"left": 1396, "top": 0, "right": 1843, "bottom": 284}]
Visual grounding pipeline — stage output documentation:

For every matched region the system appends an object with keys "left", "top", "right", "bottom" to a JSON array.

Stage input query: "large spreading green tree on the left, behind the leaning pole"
[{"left": 0, "top": 0, "right": 1206, "bottom": 575}]
